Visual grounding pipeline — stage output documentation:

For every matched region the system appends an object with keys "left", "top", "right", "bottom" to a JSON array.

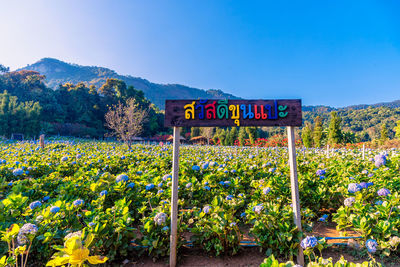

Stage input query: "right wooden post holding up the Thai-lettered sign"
[{"left": 287, "top": 126, "right": 304, "bottom": 266}]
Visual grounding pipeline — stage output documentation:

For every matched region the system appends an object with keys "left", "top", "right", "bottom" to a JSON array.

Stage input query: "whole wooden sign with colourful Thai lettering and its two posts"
[{"left": 164, "top": 99, "right": 304, "bottom": 267}]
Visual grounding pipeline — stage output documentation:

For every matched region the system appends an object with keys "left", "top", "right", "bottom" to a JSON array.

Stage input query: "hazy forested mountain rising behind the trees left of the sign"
[{"left": 21, "top": 58, "right": 239, "bottom": 109}]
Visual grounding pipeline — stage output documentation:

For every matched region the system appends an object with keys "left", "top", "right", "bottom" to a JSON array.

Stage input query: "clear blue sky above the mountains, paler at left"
[{"left": 0, "top": 0, "right": 400, "bottom": 107}]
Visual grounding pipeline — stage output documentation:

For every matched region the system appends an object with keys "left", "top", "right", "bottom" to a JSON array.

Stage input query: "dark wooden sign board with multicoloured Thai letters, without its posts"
[{"left": 164, "top": 99, "right": 302, "bottom": 127}]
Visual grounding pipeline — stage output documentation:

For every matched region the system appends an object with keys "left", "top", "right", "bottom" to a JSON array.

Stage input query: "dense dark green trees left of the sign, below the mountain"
[{"left": 0, "top": 64, "right": 165, "bottom": 138}]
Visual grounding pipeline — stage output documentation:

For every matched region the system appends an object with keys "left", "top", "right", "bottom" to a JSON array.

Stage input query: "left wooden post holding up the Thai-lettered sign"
[{"left": 169, "top": 127, "right": 180, "bottom": 267}]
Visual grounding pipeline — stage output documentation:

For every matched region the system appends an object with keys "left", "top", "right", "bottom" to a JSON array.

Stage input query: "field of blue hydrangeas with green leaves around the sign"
[{"left": 0, "top": 141, "right": 400, "bottom": 266}]
